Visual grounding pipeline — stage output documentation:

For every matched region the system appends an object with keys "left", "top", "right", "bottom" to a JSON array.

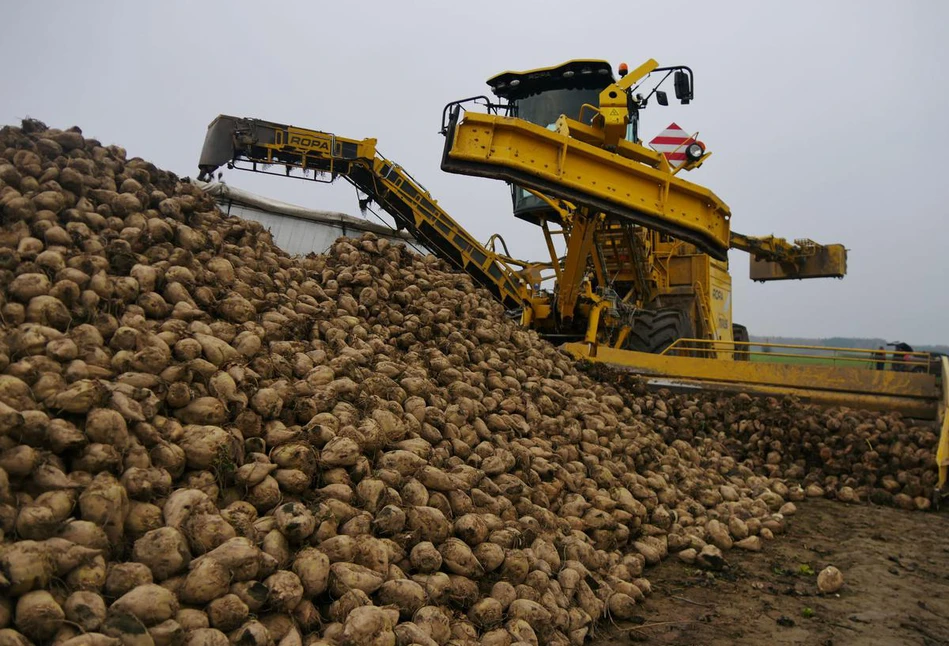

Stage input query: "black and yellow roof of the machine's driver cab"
[{"left": 488, "top": 58, "right": 614, "bottom": 101}]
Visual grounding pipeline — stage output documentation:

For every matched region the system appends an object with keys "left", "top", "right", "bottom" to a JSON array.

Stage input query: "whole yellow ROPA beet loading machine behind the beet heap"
[{"left": 199, "top": 60, "right": 949, "bottom": 494}]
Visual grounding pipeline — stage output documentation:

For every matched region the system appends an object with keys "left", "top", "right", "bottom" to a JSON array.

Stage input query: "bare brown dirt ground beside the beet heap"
[{"left": 593, "top": 500, "right": 949, "bottom": 646}]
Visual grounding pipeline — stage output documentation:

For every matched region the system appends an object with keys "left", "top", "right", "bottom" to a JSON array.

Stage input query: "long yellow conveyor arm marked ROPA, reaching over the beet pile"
[{"left": 199, "top": 115, "right": 529, "bottom": 308}]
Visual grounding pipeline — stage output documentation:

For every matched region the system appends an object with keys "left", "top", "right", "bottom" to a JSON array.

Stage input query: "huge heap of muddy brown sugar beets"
[{"left": 0, "top": 120, "right": 935, "bottom": 646}]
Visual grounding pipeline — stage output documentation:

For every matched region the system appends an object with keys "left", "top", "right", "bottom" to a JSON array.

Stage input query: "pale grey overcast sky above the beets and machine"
[{"left": 0, "top": 0, "right": 949, "bottom": 344}]
